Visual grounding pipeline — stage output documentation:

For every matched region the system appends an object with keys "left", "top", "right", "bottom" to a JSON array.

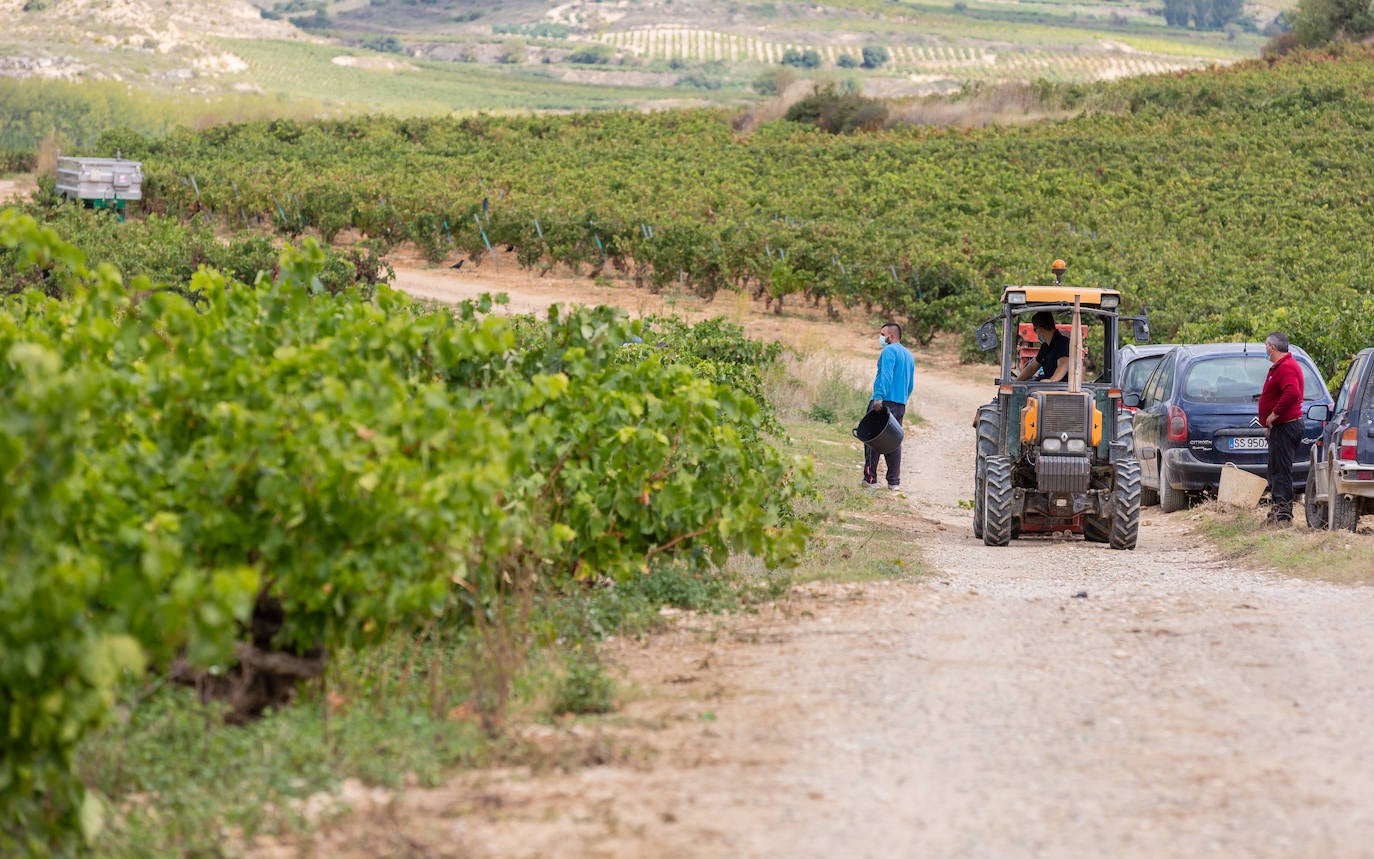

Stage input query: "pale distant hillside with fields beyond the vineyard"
[{"left": 0, "top": 0, "right": 1276, "bottom": 113}]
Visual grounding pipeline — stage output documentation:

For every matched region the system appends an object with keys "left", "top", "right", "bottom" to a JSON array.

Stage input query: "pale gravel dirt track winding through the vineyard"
[{"left": 251, "top": 263, "right": 1374, "bottom": 859}]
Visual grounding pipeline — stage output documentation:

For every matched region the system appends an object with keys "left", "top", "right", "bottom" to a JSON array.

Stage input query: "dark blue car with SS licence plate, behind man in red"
[{"left": 1123, "top": 344, "right": 1331, "bottom": 513}]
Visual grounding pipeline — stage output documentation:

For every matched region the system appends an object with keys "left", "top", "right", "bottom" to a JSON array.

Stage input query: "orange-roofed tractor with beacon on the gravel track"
[{"left": 973, "top": 260, "right": 1150, "bottom": 548}]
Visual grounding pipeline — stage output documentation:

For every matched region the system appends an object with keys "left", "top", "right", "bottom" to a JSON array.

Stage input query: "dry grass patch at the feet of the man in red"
[{"left": 1195, "top": 499, "right": 1374, "bottom": 584}]
